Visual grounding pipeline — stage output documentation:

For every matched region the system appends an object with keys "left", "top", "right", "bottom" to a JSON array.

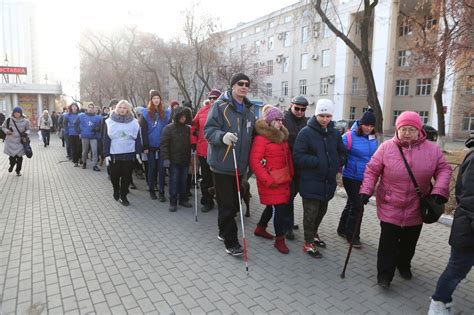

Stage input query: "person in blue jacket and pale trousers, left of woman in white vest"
[{"left": 75, "top": 103, "right": 102, "bottom": 172}]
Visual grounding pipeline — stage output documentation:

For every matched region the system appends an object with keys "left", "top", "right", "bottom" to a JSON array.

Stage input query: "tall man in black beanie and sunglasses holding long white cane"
[{"left": 204, "top": 73, "right": 255, "bottom": 256}]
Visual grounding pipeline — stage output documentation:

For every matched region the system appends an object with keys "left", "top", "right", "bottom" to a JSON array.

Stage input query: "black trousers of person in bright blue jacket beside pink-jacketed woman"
[{"left": 337, "top": 177, "right": 363, "bottom": 241}]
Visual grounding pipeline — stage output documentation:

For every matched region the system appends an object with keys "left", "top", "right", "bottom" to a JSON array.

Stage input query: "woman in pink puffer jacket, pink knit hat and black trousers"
[{"left": 360, "top": 111, "right": 452, "bottom": 288}]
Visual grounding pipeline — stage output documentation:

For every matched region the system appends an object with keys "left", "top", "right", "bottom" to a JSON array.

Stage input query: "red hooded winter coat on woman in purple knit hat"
[{"left": 250, "top": 119, "right": 294, "bottom": 205}]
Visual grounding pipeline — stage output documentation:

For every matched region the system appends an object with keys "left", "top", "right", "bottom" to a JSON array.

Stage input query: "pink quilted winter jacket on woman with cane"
[{"left": 360, "top": 130, "right": 452, "bottom": 226}]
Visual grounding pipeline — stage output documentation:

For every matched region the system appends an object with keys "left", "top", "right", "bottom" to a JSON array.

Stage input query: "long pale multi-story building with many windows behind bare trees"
[{"left": 226, "top": 0, "right": 474, "bottom": 138}]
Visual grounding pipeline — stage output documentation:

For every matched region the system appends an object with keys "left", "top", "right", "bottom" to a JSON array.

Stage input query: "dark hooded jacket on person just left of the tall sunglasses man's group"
[{"left": 160, "top": 106, "right": 191, "bottom": 166}]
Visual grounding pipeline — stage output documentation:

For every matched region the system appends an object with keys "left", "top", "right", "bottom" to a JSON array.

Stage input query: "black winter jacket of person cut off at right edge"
[{"left": 449, "top": 148, "right": 474, "bottom": 250}]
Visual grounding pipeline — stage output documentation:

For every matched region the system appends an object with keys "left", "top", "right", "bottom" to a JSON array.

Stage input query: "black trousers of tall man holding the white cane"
[{"left": 213, "top": 173, "right": 242, "bottom": 248}]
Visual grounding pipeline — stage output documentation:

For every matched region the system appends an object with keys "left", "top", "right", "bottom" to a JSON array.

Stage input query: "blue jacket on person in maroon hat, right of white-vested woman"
[{"left": 139, "top": 108, "right": 171, "bottom": 151}]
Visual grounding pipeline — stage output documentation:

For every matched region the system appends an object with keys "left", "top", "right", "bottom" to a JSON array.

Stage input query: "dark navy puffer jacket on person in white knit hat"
[{"left": 293, "top": 116, "right": 346, "bottom": 201}]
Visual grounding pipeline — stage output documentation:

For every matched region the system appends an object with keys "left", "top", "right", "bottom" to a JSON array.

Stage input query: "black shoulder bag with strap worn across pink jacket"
[{"left": 398, "top": 146, "right": 444, "bottom": 224}]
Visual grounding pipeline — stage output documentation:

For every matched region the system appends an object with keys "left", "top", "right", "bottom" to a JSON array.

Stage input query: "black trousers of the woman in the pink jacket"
[{"left": 377, "top": 222, "right": 423, "bottom": 281}]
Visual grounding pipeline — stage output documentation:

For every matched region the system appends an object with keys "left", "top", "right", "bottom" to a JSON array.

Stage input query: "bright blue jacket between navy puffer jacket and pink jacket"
[{"left": 342, "top": 121, "right": 378, "bottom": 181}]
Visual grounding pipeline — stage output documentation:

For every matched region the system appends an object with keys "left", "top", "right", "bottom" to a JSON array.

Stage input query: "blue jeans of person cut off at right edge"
[{"left": 432, "top": 247, "right": 474, "bottom": 303}]
